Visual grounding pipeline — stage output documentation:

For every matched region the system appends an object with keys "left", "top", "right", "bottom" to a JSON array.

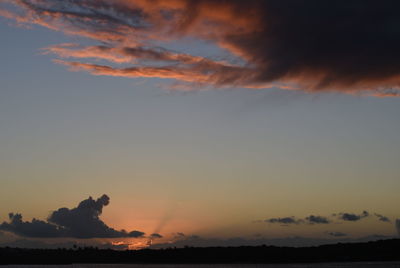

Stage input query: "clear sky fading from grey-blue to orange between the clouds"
[{"left": 0, "top": 0, "right": 400, "bottom": 248}]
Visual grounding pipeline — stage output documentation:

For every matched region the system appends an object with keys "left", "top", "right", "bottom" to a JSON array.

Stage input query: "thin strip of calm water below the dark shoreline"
[{"left": 3, "top": 262, "right": 400, "bottom": 268}]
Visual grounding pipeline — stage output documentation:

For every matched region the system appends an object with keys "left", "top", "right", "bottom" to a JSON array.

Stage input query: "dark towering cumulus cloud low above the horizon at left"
[{"left": 0, "top": 195, "right": 144, "bottom": 238}]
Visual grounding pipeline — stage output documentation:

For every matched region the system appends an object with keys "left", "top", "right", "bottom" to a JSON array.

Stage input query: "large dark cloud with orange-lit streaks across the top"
[{"left": 0, "top": 0, "right": 400, "bottom": 97}]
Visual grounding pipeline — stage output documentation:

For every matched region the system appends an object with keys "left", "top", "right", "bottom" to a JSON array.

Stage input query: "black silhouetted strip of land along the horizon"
[{"left": 0, "top": 239, "right": 400, "bottom": 264}]
